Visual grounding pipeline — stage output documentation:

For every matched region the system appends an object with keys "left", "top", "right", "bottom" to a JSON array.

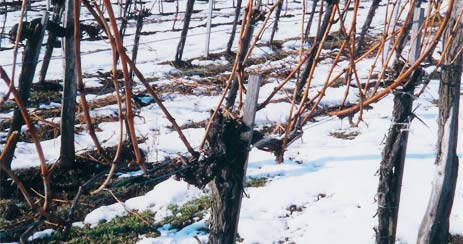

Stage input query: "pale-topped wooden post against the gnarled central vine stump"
[{"left": 209, "top": 75, "right": 261, "bottom": 244}]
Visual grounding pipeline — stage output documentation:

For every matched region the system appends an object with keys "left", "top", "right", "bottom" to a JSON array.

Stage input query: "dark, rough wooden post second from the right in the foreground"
[{"left": 376, "top": 3, "right": 424, "bottom": 244}]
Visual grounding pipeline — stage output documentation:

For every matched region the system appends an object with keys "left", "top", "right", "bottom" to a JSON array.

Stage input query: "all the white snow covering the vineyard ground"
[{"left": 0, "top": 1, "right": 463, "bottom": 244}]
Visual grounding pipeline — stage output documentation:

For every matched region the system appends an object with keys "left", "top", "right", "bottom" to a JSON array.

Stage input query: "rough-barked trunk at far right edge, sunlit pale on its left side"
[{"left": 417, "top": 1, "right": 463, "bottom": 244}]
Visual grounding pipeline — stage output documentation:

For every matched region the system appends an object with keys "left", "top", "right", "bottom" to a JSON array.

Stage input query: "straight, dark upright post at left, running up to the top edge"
[{"left": 60, "top": 0, "right": 80, "bottom": 167}]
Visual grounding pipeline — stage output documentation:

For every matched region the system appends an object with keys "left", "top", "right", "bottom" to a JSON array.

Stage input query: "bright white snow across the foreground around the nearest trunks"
[{"left": 75, "top": 78, "right": 463, "bottom": 244}]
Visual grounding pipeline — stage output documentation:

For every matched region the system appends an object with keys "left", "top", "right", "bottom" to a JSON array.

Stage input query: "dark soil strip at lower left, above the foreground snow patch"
[{"left": 0, "top": 143, "right": 182, "bottom": 242}]
